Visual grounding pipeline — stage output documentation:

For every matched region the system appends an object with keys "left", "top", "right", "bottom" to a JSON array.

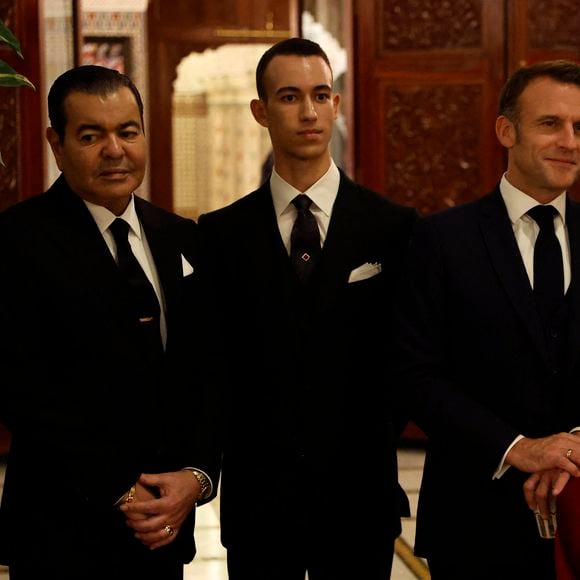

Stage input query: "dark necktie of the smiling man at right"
[{"left": 528, "top": 205, "right": 564, "bottom": 328}]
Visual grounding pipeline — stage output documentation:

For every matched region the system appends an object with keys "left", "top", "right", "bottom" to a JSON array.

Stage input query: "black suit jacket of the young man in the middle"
[{"left": 199, "top": 174, "right": 415, "bottom": 551}]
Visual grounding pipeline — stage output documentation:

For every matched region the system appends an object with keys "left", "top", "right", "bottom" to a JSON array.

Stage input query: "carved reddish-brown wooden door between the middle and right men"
[{"left": 354, "top": 0, "right": 505, "bottom": 213}]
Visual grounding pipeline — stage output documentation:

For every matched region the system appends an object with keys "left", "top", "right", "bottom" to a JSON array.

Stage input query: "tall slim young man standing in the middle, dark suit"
[{"left": 199, "top": 38, "right": 416, "bottom": 580}]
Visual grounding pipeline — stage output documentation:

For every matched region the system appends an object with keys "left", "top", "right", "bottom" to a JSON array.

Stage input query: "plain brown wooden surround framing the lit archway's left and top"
[{"left": 148, "top": 0, "right": 299, "bottom": 209}]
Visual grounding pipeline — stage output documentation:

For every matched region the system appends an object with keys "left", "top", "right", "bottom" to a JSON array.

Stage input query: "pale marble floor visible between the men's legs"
[{"left": 0, "top": 448, "right": 429, "bottom": 580}]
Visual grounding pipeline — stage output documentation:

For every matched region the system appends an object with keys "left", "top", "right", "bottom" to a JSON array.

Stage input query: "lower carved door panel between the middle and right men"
[{"left": 384, "top": 85, "right": 482, "bottom": 214}]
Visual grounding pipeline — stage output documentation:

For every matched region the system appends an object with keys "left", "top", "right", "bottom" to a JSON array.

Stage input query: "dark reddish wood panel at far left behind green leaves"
[{"left": 0, "top": 0, "right": 44, "bottom": 209}]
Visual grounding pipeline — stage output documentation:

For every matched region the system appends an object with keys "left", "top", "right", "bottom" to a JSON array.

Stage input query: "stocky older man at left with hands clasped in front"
[{"left": 0, "top": 66, "right": 220, "bottom": 580}]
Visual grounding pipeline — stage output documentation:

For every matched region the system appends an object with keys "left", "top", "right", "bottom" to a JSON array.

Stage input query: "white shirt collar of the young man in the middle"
[{"left": 270, "top": 159, "right": 340, "bottom": 218}]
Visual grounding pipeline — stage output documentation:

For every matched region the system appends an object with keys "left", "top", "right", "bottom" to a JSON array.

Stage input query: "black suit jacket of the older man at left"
[{"left": 0, "top": 177, "right": 219, "bottom": 577}]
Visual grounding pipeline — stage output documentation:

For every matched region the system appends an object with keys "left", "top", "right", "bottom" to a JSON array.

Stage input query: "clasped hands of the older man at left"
[{"left": 120, "top": 470, "right": 200, "bottom": 549}]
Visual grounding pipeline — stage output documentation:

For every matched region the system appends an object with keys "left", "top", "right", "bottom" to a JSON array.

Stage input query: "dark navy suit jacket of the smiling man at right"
[{"left": 397, "top": 189, "right": 580, "bottom": 578}]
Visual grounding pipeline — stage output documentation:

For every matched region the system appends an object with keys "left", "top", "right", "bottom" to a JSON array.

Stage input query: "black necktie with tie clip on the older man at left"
[{"left": 109, "top": 218, "right": 163, "bottom": 349}]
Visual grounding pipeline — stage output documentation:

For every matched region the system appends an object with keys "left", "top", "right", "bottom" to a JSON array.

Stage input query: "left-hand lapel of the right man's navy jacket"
[{"left": 480, "top": 189, "right": 550, "bottom": 364}]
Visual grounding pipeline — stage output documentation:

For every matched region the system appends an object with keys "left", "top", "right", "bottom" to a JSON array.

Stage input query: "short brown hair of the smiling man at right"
[{"left": 498, "top": 59, "right": 580, "bottom": 123}]
